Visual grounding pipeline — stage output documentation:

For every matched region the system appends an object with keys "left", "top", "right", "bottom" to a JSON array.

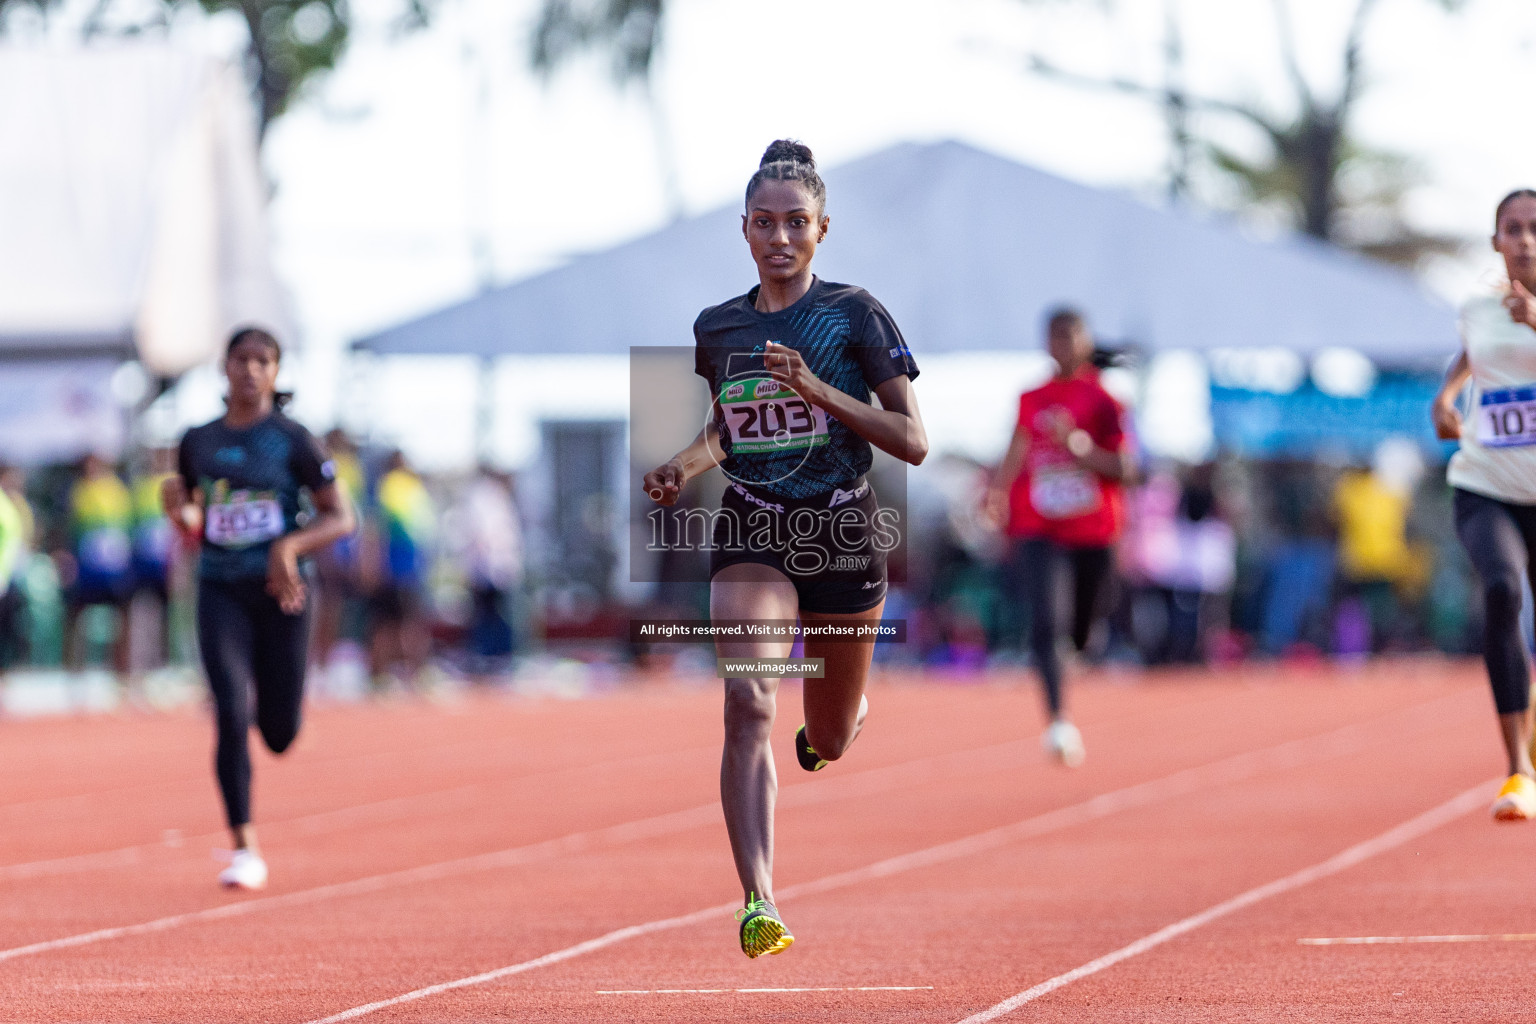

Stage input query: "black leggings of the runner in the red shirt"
[{"left": 1012, "top": 537, "right": 1111, "bottom": 717}]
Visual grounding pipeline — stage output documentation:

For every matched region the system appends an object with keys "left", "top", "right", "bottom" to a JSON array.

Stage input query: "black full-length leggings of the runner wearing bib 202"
[{"left": 197, "top": 579, "right": 309, "bottom": 827}]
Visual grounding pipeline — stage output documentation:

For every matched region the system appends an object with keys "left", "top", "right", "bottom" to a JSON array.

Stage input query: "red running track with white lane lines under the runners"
[{"left": 0, "top": 662, "right": 1536, "bottom": 1024}]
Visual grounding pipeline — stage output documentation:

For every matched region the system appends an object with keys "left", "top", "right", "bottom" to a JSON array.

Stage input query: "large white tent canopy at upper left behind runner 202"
[{"left": 0, "top": 43, "right": 289, "bottom": 376}]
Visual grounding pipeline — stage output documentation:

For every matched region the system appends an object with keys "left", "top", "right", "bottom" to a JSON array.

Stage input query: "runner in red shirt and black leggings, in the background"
[{"left": 988, "top": 309, "right": 1132, "bottom": 766}]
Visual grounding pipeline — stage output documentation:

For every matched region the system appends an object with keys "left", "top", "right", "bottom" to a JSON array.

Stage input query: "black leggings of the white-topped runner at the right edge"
[{"left": 1455, "top": 488, "right": 1536, "bottom": 715}]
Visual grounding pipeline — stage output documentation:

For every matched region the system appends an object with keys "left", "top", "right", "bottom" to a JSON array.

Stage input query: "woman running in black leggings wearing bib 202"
[{"left": 161, "top": 329, "right": 353, "bottom": 889}]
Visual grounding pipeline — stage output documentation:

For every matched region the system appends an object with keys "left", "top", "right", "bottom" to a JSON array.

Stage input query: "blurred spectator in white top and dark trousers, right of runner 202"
[{"left": 458, "top": 467, "right": 522, "bottom": 669}]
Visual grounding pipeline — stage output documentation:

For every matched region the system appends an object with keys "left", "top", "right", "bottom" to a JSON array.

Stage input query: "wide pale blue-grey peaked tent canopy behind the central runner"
[{"left": 355, "top": 143, "right": 1456, "bottom": 364}]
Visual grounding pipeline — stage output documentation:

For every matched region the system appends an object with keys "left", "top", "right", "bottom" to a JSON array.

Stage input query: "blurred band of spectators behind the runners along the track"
[{"left": 0, "top": 420, "right": 1481, "bottom": 695}]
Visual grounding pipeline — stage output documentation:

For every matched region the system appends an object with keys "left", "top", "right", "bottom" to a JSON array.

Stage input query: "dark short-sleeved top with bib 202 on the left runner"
[{"left": 177, "top": 411, "right": 336, "bottom": 582}]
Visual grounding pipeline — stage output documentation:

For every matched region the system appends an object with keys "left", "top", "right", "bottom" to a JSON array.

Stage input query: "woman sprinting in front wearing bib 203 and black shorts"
[{"left": 644, "top": 140, "right": 928, "bottom": 956}]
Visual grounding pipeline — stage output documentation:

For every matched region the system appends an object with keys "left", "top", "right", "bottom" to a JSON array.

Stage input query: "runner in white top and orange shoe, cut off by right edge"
[{"left": 1432, "top": 189, "right": 1536, "bottom": 821}]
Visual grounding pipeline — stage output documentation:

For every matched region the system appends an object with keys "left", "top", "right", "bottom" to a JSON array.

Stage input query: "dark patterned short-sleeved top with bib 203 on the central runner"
[{"left": 693, "top": 278, "right": 917, "bottom": 497}]
